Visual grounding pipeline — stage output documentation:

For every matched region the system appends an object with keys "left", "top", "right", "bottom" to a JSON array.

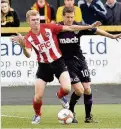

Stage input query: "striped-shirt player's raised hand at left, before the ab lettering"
[{"left": 11, "top": 33, "right": 25, "bottom": 48}]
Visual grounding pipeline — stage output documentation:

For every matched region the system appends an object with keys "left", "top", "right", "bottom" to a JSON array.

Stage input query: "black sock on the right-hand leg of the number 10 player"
[{"left": 84, "top": 94, "right": 92, "bottom": 118}]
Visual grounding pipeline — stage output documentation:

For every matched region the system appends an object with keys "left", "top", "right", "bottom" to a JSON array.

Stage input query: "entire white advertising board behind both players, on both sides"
[{"left": 0, "top": 36, "right": 121, "bottom": 86}]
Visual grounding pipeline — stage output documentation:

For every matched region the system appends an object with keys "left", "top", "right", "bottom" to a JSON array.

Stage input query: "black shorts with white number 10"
[{"left": 65, "top": 56, "right": 91, "bottom": 84}]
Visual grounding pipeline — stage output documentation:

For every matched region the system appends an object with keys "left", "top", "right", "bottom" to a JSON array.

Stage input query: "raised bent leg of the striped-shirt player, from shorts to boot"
[{"left": 52, "top": 58, "right": 71, "bottom": 109}]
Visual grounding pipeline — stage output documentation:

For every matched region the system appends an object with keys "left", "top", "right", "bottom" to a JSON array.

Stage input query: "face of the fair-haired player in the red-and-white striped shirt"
[{"left": 27, "top": 15, "right": 40, "bottom": 28}]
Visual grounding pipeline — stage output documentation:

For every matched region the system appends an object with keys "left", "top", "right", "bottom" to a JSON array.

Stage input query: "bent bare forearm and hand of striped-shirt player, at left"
[{"left": 11, "top": 34, "right": 31, "bottom": 58}]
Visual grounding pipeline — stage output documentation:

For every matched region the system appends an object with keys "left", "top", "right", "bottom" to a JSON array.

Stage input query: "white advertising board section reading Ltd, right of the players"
[{"left": 80, "top": 35, "right": 121, "bottom": 84}]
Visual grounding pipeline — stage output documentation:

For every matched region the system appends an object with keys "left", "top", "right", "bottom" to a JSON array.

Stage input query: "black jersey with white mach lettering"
[{"left": 58, "top": 21, "right": 96, "bottom": 58}]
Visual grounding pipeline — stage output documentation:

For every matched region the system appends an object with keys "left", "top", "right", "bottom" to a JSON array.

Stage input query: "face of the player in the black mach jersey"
[{"left": 63, "top": 12, "right": 74, "bottom": 26}]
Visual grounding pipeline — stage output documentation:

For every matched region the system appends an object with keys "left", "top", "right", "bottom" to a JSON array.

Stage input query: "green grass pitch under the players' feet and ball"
[{"left": 1, "top": 104, "right": 121, "bottom": 128}]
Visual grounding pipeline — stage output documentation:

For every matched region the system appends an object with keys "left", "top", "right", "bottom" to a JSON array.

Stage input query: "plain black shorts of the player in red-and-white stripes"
[{"left": 36, "top": 58, "right": 67, "bottom": 82}]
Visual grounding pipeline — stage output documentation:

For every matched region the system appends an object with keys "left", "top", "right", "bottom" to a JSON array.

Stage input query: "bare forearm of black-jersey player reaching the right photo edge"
[{"left": 96, "top": 28, "right": 121, "bottom": 39}]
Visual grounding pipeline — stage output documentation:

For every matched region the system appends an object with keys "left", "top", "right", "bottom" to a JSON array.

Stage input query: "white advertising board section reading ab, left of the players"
[{"left": 0, "top": 37, "right": 59, "bottom": 86}]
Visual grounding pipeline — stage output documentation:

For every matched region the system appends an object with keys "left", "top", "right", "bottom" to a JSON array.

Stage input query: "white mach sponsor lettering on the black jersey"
[{"left": 59, "top": 36, "right": 79, "bottom": 44}]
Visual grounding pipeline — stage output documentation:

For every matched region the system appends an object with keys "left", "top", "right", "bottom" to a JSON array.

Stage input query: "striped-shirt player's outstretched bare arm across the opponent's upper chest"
[{"left": 62, "top": 21, "right": 101, "bottom": 31}]
